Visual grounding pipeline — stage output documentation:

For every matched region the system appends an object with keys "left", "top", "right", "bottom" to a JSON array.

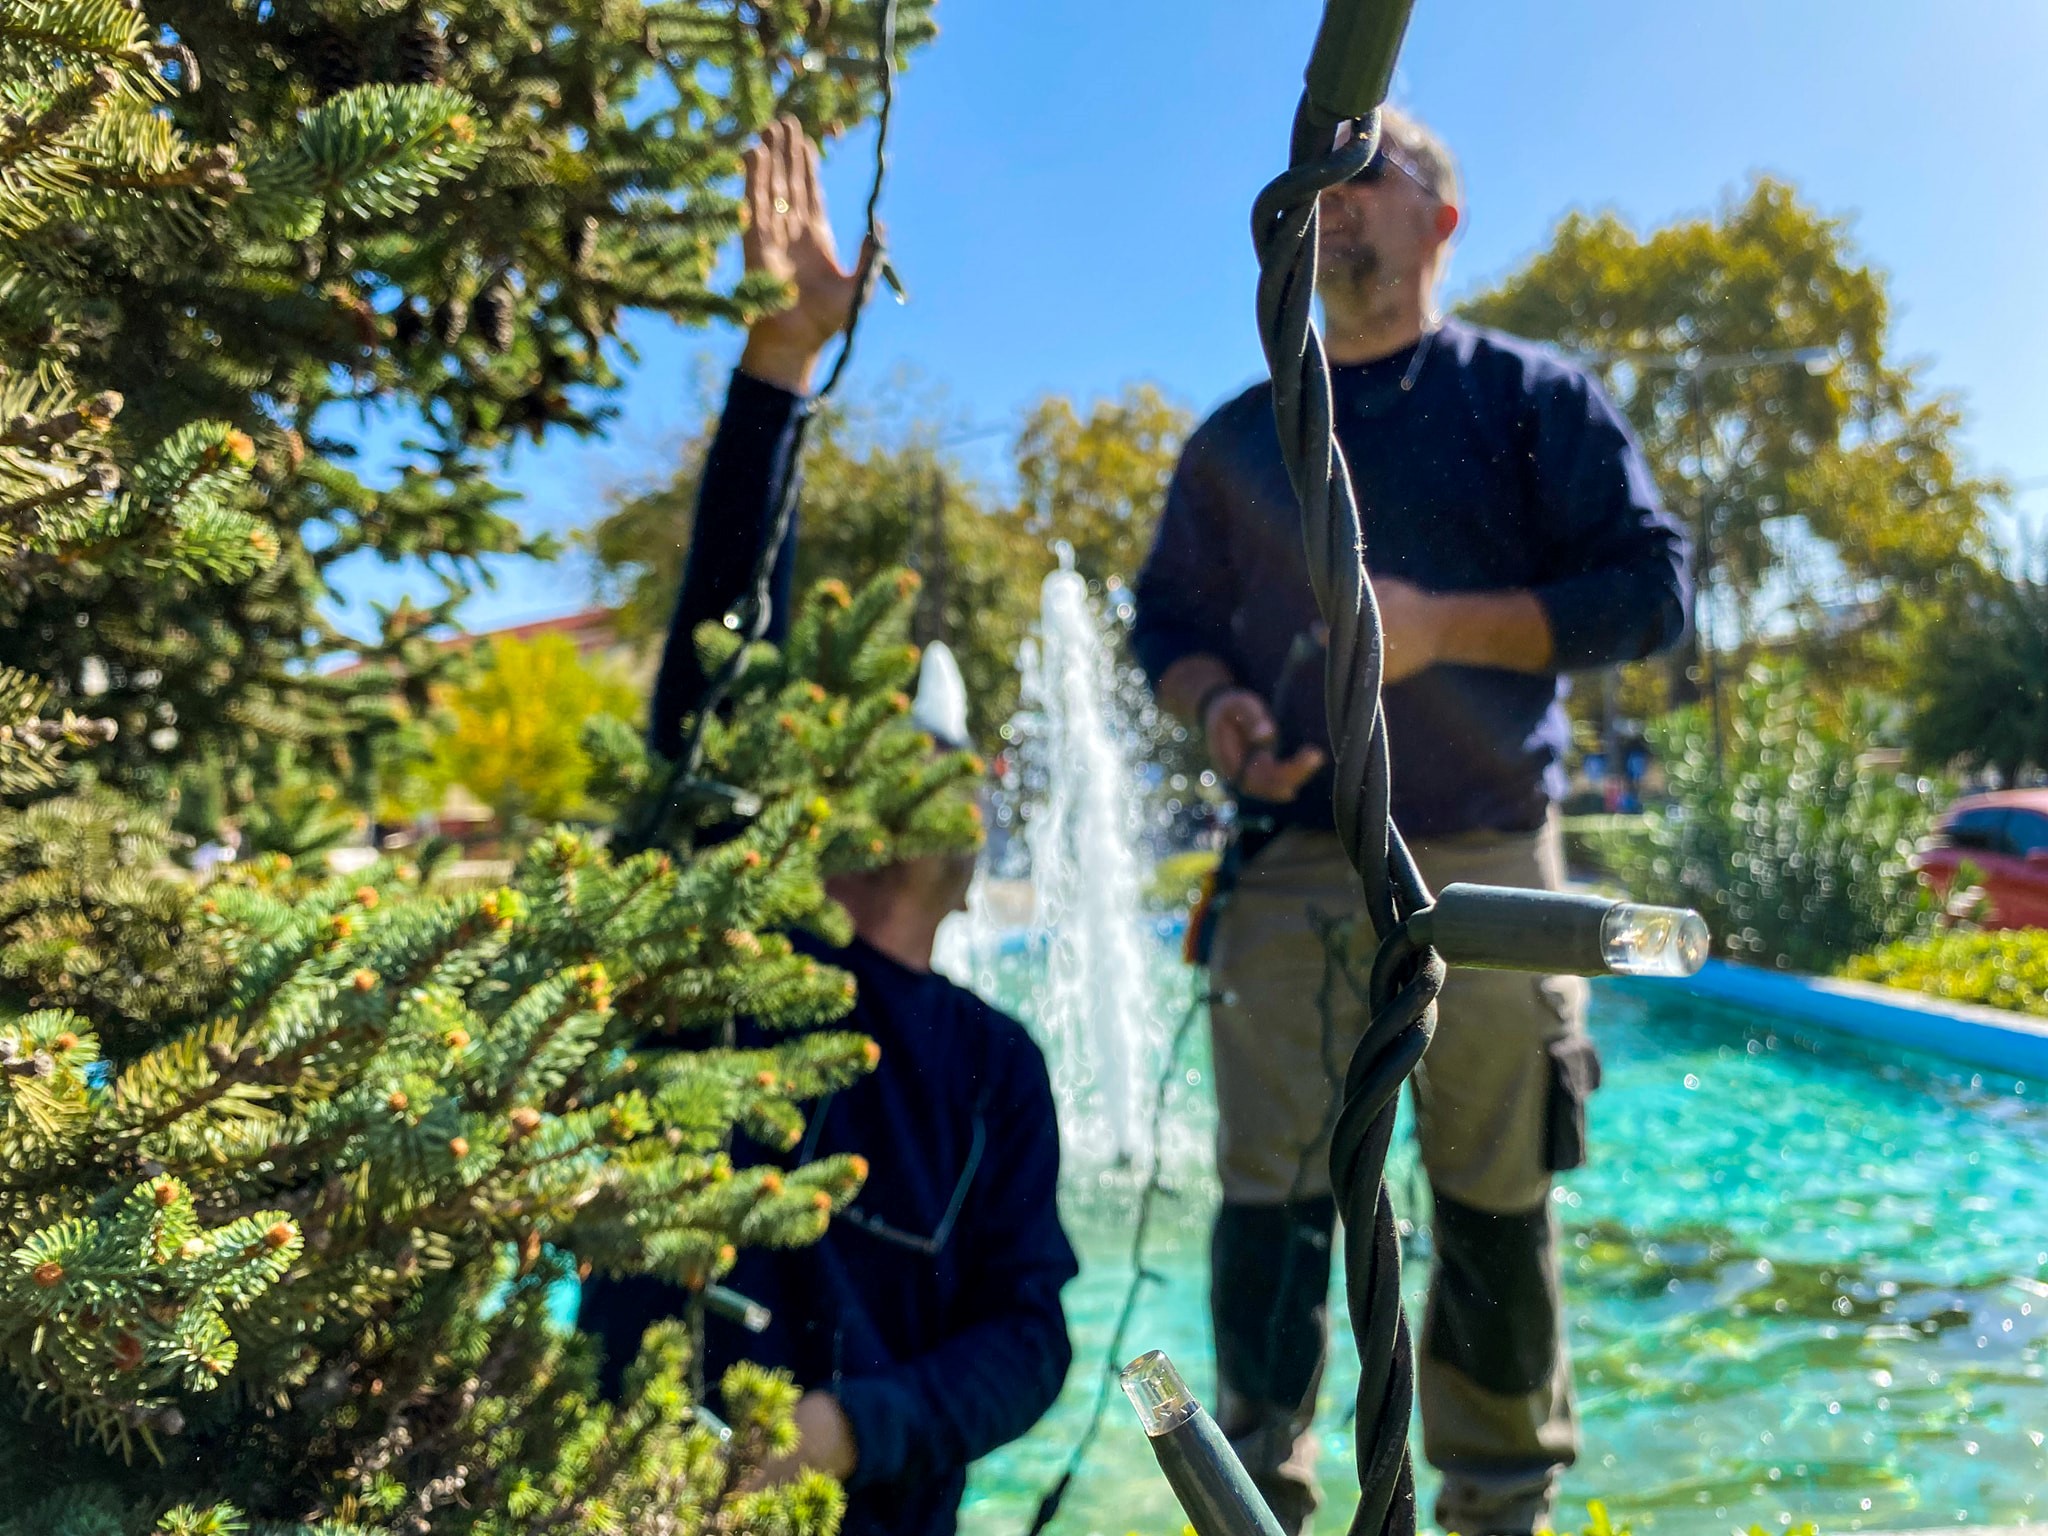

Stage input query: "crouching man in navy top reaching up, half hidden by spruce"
[{"left": 582, "top": 121, "right": 1077, "bottom": 1536}]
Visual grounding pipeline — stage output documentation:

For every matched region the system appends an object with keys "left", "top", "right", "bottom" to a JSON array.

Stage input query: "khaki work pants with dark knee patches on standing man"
[{"left": 1210, "top": 821, "right": 1597, "bottom": 1536}]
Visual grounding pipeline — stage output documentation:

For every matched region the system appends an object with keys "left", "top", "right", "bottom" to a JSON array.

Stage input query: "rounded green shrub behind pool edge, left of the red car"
[{"left": 1599, "top": 666, "right": 1939, "bottom": 973}]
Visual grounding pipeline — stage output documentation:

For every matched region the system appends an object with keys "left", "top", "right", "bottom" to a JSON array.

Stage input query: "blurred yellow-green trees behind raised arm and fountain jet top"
[{"left": 588, "top": 385, "right": 1190, "bottom": 745}]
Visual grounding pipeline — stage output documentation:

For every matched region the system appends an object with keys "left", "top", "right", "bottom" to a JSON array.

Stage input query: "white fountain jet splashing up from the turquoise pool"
[{"left": 938, "top": 545, "right": 1180, "bottom": 1169}]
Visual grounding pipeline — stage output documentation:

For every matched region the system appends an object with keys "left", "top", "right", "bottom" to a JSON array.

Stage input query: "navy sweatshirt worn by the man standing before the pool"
[{"left": 1130, "top": 324, "right": 1690, "bottom": 838}]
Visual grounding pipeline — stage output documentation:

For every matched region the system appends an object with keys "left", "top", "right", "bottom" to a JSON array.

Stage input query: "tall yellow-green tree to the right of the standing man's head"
[{"left": 1460, "top": 178, "right": 2003, "bottom": 704}]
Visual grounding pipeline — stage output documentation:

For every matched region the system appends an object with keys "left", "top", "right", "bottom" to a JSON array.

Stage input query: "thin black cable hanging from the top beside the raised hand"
[{"left": 614, "top": 0, "right": 897, "bottom": 852}]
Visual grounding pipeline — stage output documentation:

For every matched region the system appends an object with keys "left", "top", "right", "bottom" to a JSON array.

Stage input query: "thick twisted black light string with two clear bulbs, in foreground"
[{"left": 1124, "top": 0, "right": 1706, "bottom": 1536}]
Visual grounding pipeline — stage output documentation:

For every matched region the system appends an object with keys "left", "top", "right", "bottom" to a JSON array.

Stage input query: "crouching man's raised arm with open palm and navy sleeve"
[{"left": 647, "top": 119, "right": 854, "bottom": 758}]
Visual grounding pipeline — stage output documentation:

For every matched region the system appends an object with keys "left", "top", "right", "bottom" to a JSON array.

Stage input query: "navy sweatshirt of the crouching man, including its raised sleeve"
[{"left": 582, "top": 373, "right": 1079, "bottom": 1536}]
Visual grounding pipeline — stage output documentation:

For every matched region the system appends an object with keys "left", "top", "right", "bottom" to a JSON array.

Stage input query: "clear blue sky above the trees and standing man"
[{"left": 336, "top": 0, "right": 2048, "bottom": 627}]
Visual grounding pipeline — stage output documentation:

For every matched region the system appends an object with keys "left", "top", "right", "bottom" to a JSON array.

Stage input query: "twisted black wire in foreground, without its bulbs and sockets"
[{"left": 1251, "top": 98, "right": 1444, "bottom": 1536}]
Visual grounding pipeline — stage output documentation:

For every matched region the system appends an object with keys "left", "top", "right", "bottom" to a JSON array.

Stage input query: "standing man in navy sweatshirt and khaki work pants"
[{"left": 1133, "top": 113, "right": 1686, "bottom": 1536}]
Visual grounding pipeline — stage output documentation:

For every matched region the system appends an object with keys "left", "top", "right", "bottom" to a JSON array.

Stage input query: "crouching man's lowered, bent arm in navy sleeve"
[{"left": 834, "top": 1036, "right": 1079, "bottom": 1489}]
